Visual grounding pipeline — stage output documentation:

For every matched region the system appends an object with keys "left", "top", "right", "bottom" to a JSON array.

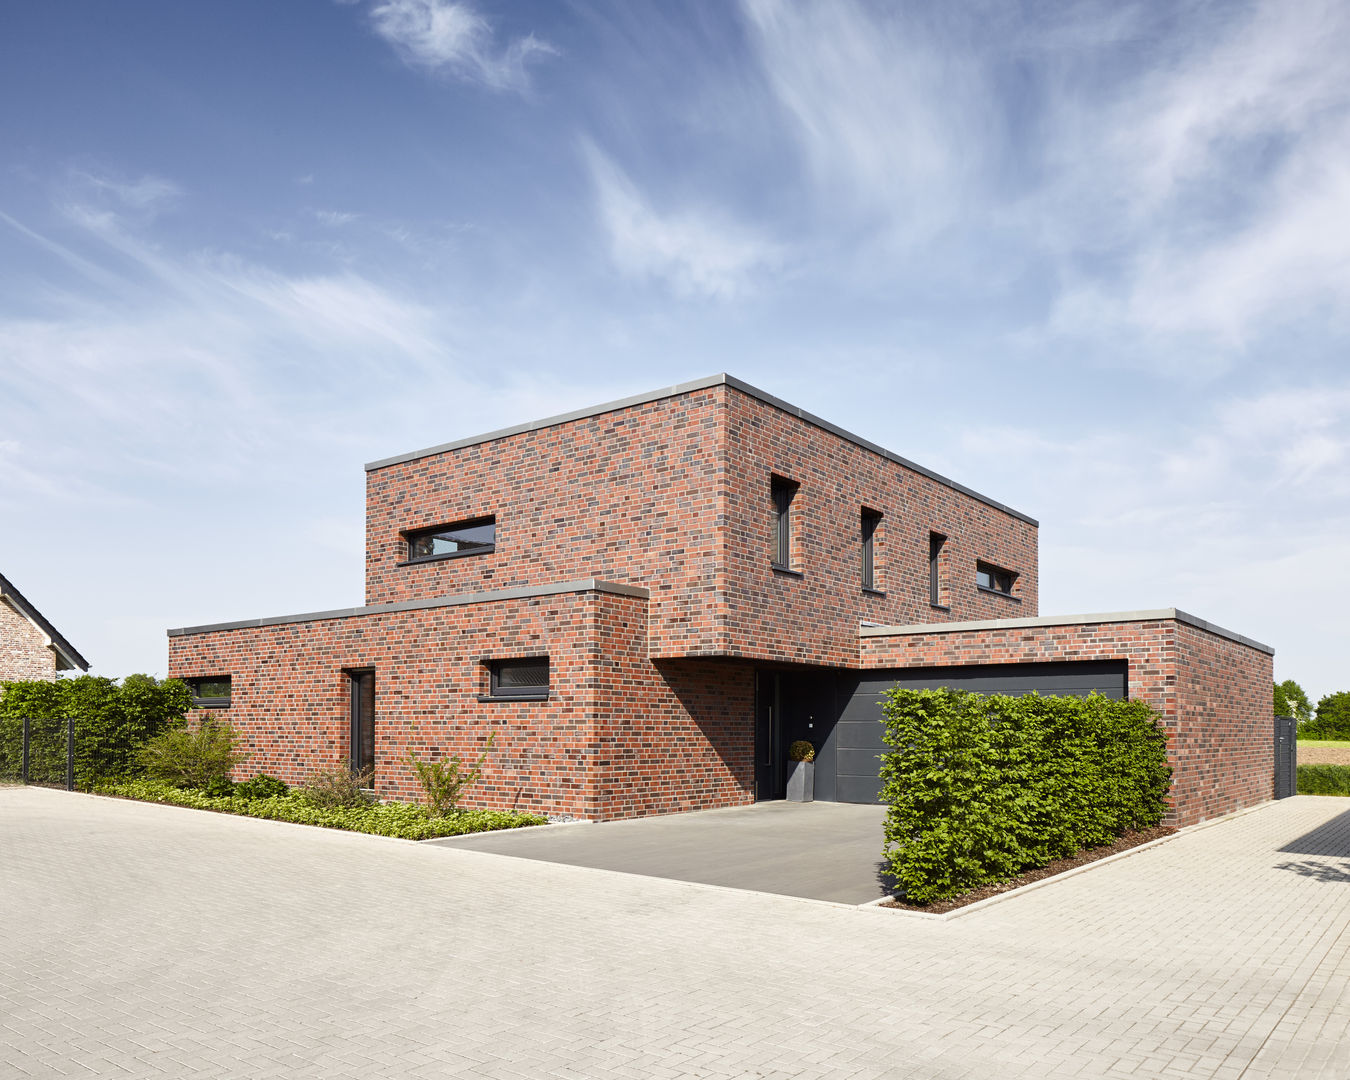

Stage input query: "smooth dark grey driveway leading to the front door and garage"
[{"left": 427, "top": 802, "right": 888, "bottom": 903}]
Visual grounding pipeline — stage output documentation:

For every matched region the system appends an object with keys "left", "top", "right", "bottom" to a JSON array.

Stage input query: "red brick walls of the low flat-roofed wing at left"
[{"left": 169, "top": 591, "right": 753, "bottom": 819}]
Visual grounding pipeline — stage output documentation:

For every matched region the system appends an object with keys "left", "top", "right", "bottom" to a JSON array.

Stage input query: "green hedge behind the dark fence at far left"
[{"left": 0, "top": 675, "right": 192, "bottom": 788}]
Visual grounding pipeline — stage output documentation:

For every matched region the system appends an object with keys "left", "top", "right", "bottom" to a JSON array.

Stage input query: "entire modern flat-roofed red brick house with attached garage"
[{"left": 169, "top": 375, "right": 1272, "bottom": 824}]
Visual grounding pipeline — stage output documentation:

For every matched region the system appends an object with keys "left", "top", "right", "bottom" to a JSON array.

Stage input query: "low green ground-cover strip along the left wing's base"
[{"left": 93, "top": 780, "right": 548, "bottom": 840}]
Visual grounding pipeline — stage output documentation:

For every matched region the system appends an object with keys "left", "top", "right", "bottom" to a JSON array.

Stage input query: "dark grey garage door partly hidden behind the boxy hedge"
[{"left": 833, "top": 660, "right": 1127, "bottom": 802}]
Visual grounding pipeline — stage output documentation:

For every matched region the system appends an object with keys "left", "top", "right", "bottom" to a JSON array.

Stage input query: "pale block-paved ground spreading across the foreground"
[{"left": 0, "top": 788, "right": 1350, "bottom": 1080}]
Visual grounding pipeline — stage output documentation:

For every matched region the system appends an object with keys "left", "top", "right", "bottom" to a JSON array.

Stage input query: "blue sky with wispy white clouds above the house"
[{"left": 0, "top": 0, "right": 1350, "bottom": 697}]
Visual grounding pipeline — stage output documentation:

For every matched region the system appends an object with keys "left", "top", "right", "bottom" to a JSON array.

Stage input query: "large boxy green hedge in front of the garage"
[{"left": 882, "top": 687, "right": 1172, "bottom": 903}]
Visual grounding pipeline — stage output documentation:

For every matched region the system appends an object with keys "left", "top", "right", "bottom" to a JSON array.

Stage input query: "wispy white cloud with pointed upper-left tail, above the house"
[{"left": 583, "top": 144, "right": 783, "bottom": 300}]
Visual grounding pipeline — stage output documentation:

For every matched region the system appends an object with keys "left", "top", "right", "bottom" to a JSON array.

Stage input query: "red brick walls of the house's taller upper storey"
[{"left": 366, "top": 385, "right": 1038, "bottom": 664}]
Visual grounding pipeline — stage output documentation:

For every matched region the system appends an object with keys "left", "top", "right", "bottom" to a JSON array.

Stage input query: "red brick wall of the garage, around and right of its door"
[{"left": 861, "top": 618, "right": 1274, "bottom": 825}]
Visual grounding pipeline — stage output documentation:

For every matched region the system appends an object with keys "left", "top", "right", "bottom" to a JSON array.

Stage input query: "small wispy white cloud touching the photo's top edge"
[{"left": 370, "top": 0, "right": 558, "bottom": 90}]
